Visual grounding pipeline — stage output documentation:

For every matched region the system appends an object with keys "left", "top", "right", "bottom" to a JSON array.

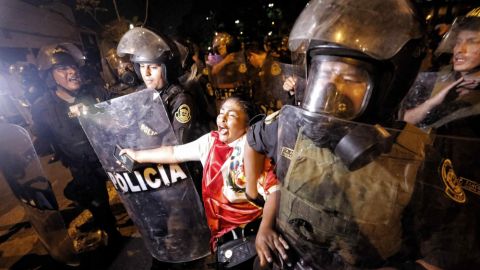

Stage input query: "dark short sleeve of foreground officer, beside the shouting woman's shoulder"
[{"left": 247, "top": 111, "right": 280, "bottom": 160}]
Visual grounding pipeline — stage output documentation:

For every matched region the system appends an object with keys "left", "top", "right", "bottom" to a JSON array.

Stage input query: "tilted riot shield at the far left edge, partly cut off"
[{"left": 0, "top": 124, "right": 79, "bottom": 265}]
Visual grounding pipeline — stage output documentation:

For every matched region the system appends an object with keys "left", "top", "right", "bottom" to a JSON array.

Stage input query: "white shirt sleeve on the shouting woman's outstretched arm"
[{"left": 173, "top": 133, "right": 213, "bottom": 165}]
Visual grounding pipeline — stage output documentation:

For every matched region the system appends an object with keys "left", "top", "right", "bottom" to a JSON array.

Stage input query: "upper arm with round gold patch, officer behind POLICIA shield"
[{"left": 169, "top": 93, "right": 198, "bottom": 144}]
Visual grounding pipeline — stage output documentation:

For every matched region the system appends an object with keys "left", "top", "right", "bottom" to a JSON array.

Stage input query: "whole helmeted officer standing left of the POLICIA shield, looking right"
[{"left": 32, "top": 43, "right": 121, "bottom": 245}]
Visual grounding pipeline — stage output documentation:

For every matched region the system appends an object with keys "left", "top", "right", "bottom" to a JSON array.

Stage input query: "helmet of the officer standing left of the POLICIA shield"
[{"left": 37, "top": 43, "right": 85, "bottom": 88}]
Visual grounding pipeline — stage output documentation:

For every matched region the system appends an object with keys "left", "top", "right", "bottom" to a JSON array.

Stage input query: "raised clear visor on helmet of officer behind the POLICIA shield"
[{"left": 117, "top": 27, "right": 170, "bottom": 61}]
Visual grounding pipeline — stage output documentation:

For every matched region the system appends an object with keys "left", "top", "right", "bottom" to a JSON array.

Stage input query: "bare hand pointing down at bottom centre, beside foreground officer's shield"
[{"left": 255, "top": 227, "right": 289, "bottom": 267}]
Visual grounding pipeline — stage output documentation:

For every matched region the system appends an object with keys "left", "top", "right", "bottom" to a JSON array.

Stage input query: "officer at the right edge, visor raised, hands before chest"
[{"left": 404, "top": 7, "right": 480, "bottom": 269}]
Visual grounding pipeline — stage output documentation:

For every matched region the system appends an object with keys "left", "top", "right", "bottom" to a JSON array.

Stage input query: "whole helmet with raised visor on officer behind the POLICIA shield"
[{"left": 117, "top": 27, "right": 181, "bottom": 85}]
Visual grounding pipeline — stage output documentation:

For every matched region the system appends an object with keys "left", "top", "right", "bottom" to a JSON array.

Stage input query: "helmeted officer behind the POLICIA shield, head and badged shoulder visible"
[{"left": 117, "top": 27, "right": 198, "bottom": 146}]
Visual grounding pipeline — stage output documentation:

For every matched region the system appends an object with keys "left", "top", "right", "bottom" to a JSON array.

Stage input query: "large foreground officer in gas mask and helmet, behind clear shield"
[{"left": 245, "top": 0, "right": 442, "bottom": 269}]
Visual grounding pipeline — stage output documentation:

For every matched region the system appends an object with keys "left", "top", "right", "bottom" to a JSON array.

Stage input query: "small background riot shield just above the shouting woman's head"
[{"left": 206, "top": 53, "right": 250, "bottom": 100}]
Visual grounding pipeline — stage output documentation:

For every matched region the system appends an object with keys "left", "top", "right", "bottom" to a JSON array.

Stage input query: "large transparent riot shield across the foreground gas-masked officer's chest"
[{"left": 276, "top": 106, "right": 480, "bottom": 269}]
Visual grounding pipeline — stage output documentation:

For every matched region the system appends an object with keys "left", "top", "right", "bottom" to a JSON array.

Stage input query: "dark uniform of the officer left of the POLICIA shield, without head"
[{"left": 32, "top": 85, "right": 118, "bottom": 233}]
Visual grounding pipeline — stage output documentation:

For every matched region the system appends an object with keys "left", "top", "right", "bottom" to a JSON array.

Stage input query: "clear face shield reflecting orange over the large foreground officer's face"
[{"left": 302, "top": 56, "right": 372, "bottom": 119}]
